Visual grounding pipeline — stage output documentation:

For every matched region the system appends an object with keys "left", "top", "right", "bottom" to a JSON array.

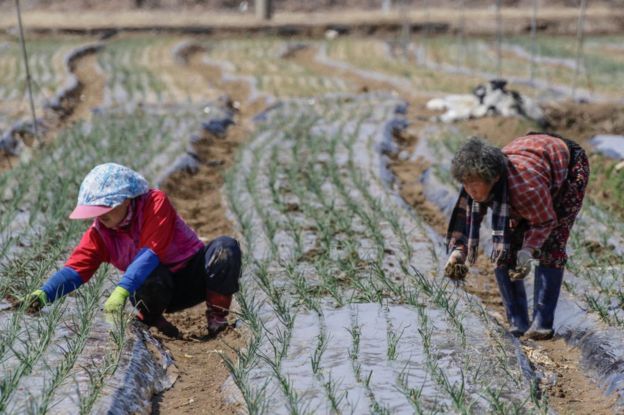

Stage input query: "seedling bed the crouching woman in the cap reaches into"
[{"left": 0, "top": 106, "right": 198, "bottom": 413}]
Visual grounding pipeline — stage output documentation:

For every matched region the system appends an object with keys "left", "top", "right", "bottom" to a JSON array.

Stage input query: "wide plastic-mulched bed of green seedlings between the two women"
[{"left": 226, "top": 96, "right": 535, "bottom": 413}]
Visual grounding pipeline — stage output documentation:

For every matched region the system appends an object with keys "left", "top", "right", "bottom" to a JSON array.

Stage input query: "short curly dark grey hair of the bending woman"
[{"left": 451, "top": 137, "right": 507, "bottom": 183}]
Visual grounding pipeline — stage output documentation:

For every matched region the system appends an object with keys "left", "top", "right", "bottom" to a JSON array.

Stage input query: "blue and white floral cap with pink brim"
[{"left": 69, "top": 163, "right": 149, "bottom": 219}]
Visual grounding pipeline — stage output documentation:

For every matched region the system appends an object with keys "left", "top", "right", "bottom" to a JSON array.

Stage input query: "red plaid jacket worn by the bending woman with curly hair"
[{"left": 503, "top": 135, "right": 570, "bottom": 249}]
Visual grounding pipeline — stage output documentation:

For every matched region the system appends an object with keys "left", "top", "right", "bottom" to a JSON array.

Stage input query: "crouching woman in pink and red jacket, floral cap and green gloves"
[{"left": 22, "top": 163, "right": 242, "bottom": 337}]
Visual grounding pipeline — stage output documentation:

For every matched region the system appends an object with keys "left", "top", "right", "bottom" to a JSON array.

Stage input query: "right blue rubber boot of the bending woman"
[{"left": 526, "top": 266, "right": 564, "bottom": 340}]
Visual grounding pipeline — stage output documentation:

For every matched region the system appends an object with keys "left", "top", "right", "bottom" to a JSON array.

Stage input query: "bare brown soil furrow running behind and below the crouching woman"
[{"left": 152, "top": 47, "right": 265, "bottom": 415}]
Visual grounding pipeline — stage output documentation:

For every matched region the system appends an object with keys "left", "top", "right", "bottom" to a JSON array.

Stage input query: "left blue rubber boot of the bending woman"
[{"left": 494, "top": 267, "right": 529, "bottom": 337}]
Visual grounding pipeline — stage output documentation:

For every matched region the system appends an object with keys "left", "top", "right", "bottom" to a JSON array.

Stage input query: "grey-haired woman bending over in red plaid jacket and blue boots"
[{"left": 445, "top": 133, "right": 589, "bottom": 340}]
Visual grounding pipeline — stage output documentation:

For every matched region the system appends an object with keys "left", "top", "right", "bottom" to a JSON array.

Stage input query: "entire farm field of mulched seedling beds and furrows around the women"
[{"left": 0, "top": 22, "right": 624, "bottom": 414}]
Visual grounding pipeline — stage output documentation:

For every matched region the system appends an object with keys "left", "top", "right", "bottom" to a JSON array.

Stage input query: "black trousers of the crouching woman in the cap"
[{"left": 132, "top": 236, "right": 242, "bottom": 325}]
